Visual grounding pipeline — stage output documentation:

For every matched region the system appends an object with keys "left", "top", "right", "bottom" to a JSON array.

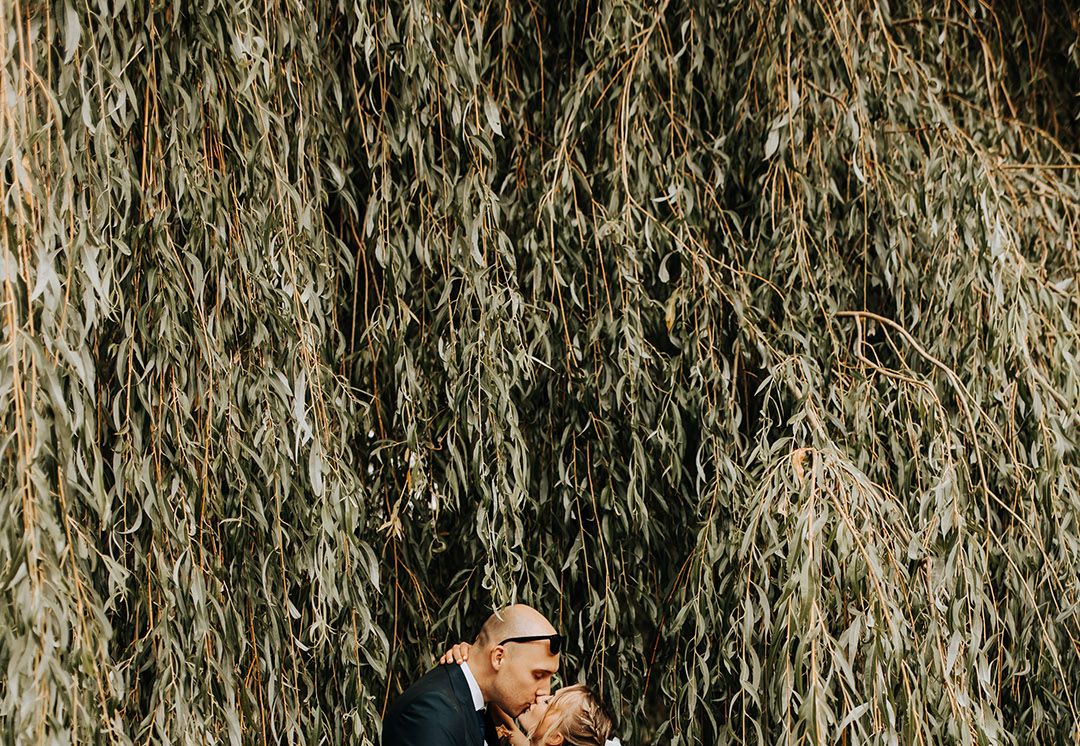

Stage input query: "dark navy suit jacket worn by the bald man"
[{"left": 382, "top": 665, "right": 486, "bottom": 746}]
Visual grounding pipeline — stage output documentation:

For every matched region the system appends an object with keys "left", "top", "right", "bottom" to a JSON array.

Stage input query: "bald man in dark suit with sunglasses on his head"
[{"left": 382, "top": 605, "right": 563, "bottom": 746}]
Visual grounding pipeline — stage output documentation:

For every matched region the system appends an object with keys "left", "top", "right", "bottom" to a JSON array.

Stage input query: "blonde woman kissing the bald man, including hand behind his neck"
[{"left": 438, "top": 642, "right": 621, "bottom": 746}]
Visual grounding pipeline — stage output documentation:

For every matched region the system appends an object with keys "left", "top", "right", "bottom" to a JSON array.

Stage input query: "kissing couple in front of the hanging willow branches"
[{"left": 381, "top": 605, "right": 620, "bottom": 746}]
